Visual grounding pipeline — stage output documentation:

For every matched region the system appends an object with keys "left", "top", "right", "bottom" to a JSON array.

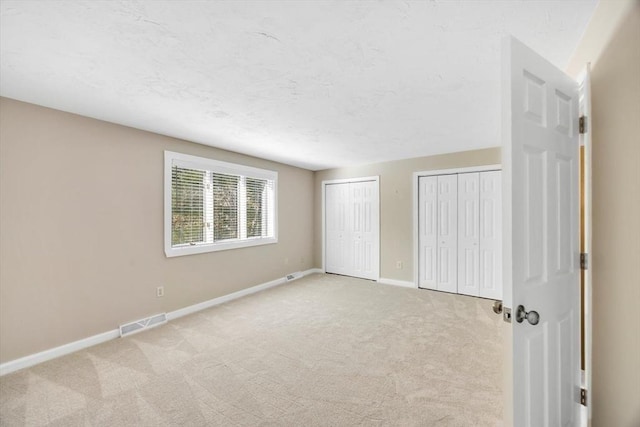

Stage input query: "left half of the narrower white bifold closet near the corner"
[{"left": 325, "top": 184, "right": 351, "bottom": 274}]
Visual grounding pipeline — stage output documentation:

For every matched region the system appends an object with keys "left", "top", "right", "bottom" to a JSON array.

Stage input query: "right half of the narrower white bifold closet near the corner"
[{"left": 348, "top": 181, "right": 379, "bottom": 280}]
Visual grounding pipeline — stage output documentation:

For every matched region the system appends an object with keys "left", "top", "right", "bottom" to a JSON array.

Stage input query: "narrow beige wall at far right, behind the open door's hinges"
[{"left": 569, "top": 0, "right": 640, "bottom": 427}]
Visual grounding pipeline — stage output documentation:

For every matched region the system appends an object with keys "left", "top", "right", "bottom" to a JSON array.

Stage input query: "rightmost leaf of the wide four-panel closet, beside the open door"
[{"left": 478, "top": 171, "right": 502, "bottom": 300}]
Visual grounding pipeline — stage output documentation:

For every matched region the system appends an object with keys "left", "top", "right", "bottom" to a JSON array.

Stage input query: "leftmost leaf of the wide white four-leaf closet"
[{"left": 418, "top": 176, "right": 438, "bottom": 289}]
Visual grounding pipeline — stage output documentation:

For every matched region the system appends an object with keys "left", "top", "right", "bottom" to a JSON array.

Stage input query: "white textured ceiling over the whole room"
[{"left": 0, "top": 0, "right": 597, "bottom": 170}]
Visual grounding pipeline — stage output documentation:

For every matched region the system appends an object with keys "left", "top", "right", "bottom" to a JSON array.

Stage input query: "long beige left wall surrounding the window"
[{"left": 0, "top": 98, "right": 314, "bottom": 363}]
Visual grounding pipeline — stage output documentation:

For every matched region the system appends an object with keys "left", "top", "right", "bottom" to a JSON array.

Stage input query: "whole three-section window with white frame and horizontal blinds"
[{"left": 165, "top": 151, "right": 278, "bottom": 257}]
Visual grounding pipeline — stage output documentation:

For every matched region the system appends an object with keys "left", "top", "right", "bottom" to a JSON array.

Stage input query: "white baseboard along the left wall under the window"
[{"left": 0, "top": 268, "right": 323, "bottom": 376}]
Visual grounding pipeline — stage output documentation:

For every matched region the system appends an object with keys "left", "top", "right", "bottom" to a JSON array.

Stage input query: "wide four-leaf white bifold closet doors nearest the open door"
[{"left": 418, "top": 171, "right": 502, "bottom": 299}]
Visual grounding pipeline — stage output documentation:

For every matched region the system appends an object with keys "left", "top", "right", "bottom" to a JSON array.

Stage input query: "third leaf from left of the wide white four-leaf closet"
[{"left": 458, "top": 172, "right": 481, "bottom": 296}]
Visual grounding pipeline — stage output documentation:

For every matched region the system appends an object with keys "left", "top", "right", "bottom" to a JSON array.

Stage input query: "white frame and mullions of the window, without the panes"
[{"left": 164, "top": 151, "right": 278, "bottom": 257}]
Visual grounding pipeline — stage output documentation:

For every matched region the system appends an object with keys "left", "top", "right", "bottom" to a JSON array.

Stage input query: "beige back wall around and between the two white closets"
[{"left": 314, "top": 148, "right": 501, "bottom": 282}]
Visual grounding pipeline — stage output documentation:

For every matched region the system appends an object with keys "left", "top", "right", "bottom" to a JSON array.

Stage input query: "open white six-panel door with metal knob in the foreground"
[{"left": 503, "top": 38, "right": 580, "bottom": 427}]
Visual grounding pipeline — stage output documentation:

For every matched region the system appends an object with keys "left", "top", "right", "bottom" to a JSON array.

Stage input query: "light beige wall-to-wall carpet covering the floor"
[{"left": 0, "top": 274, "right": 502, "bottom": 426}]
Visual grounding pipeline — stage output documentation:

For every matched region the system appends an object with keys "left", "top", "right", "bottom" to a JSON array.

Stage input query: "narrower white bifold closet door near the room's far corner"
[{"left": 325, "top": 181, "right": 380, "bottom": 280}]
